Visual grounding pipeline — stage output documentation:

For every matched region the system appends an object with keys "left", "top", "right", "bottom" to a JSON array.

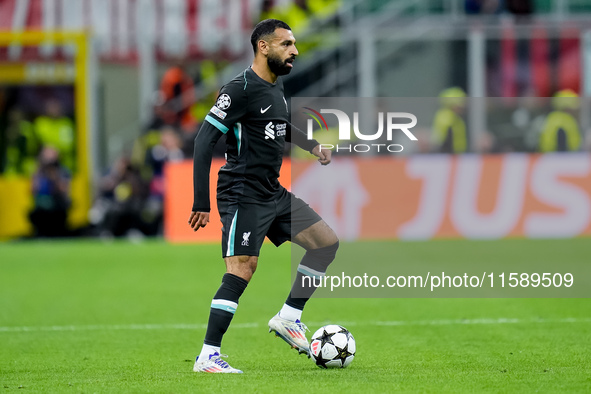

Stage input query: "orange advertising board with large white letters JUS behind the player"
[{"left": 165, "top": 153, "right": 591, "bottom": 242}]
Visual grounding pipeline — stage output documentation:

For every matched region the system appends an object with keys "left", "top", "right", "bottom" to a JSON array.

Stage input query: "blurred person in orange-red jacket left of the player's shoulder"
[{"left": 156, "top": 60, "right": 197, "bottom": 133}]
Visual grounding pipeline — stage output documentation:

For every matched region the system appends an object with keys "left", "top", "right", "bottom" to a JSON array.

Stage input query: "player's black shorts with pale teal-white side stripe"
[{"left": 218, "top": 188, "right": 322, "bottom": 257}]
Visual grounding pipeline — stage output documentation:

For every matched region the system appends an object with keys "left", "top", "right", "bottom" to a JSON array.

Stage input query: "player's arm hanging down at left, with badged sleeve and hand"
[{"left": 189, "top": 83, "right": 247, "bottom": 231}]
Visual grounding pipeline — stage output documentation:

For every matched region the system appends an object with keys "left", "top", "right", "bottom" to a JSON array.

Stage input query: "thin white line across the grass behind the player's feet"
[{"left": 0, "top": 317, "right": 591, "bottom": 332}]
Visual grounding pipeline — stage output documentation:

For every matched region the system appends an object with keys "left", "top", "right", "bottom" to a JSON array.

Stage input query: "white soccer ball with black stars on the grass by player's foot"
[{"left": 310, "top": 324, "right": 355, "bottom": 368}]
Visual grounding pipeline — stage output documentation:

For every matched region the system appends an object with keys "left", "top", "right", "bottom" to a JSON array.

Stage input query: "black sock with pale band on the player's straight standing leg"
[{"left": 203, "top": 273, "right": 248, "bottom": 347}]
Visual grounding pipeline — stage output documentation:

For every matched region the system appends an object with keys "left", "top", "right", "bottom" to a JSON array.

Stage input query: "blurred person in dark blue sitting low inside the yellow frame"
[{"left": 29, "top": 147, "right": 70, "bottom": 237}]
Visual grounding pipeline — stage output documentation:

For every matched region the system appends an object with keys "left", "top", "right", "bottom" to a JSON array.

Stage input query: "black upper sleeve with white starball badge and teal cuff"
[{"left": 205, "top": 82, "right": 248, "bottom": 134}]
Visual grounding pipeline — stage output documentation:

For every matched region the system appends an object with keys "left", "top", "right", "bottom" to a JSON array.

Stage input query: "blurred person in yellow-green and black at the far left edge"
[{"left": 3, "top": 107, "right": 40, "bottom": 176}]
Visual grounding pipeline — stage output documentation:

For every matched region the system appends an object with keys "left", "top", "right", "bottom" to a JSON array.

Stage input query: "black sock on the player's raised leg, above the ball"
[{"left": 285, "top": 242, "right": 339, "bottom": 310}]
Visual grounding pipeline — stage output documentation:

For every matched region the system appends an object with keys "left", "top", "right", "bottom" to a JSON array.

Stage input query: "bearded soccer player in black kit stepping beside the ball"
[{"left": 189, "top": 19, "right": 339, "bottom": 373}]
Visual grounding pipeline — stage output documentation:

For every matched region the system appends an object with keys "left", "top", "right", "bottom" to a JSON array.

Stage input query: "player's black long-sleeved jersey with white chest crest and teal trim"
[{"left": 193, "top": 68, "right": 318, "bottom": 212}]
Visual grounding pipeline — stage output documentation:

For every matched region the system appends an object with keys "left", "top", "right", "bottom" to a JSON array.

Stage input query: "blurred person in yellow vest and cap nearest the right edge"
[{"left": 540, "top": 89, "right": 581, "bottom": 152}]
